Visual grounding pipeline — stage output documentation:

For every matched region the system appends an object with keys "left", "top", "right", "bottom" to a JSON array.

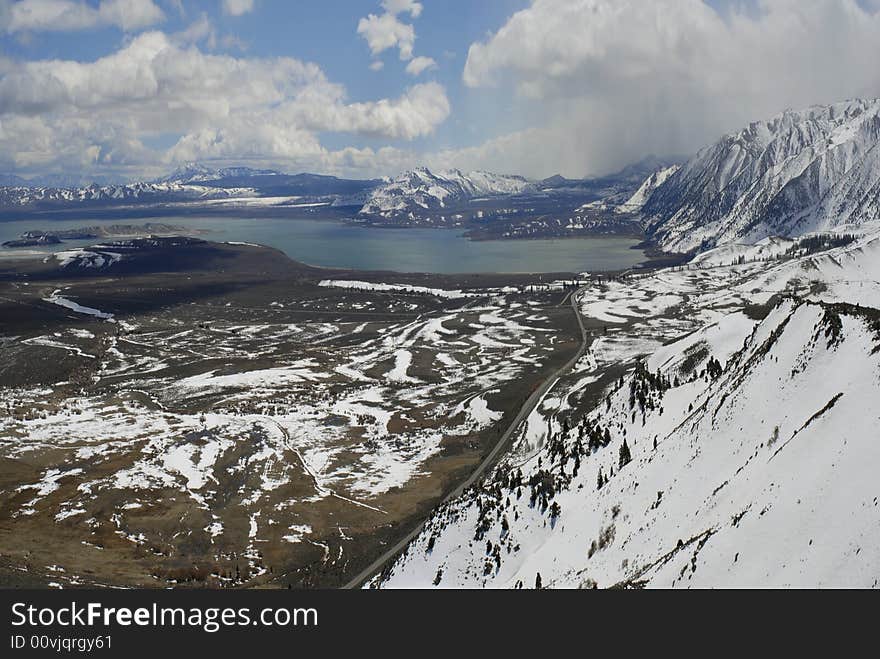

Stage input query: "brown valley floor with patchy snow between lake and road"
[{"left": 0, "top": 243, "right": 580, "bottom": 587}]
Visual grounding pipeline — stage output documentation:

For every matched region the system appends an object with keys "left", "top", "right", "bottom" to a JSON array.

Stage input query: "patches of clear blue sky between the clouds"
[{"left": 2, "top": 0, "right": 529, "bottom": 146}]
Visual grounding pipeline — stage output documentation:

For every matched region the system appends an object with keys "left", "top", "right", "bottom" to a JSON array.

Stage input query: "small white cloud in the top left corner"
[{"left": 0, "top": 0, "right": 165, "bottom": 34}]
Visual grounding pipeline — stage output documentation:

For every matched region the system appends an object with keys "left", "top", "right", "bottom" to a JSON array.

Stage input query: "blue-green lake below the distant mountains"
[{"left": 0, "top": 217, "right": 645, "bottom": 274}]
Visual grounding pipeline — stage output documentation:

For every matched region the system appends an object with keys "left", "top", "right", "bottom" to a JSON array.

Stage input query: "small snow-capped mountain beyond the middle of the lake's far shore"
[{"left": 361, "top": 167, "right": 534, "bottom": 217}]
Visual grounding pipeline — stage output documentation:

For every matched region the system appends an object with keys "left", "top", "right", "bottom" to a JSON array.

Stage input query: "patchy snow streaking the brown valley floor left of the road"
[{"left": 0, "top": 289, "right": 558, "bottom": 579}]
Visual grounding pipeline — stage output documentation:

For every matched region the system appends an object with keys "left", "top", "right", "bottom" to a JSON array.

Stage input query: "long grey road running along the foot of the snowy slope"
[{"left": 344, "top": 288, "right": 588, "bottom": 588}]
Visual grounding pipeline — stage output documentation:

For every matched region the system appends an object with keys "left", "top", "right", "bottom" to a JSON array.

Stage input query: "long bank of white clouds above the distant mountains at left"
[{"left": 0, "top": 31, "right": 450, "bottom": 177}]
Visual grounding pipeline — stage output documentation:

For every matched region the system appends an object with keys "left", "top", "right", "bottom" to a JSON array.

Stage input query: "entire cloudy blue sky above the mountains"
[{"left": 0, "top": 0, "right": 880, "bottom": 180}]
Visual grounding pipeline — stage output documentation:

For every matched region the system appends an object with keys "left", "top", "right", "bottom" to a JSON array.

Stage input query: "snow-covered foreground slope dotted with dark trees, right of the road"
[{"left": 371, "top": 223, "right": 880, "bottom": 588}]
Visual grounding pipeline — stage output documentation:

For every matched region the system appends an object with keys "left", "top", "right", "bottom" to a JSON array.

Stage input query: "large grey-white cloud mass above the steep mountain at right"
[{"left": 462, "top": 0, "right": 880, "bottom": 175}]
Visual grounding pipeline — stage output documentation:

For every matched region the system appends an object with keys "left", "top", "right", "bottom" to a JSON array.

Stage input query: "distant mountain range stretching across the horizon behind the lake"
[{"left": 0, "top": 99, "right": 880, "bottom": 254}]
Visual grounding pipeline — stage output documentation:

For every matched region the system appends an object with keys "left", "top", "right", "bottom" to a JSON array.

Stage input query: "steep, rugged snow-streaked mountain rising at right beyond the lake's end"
[{"left": 643, "top": 99, "right": 880, "bottom": 252}]
